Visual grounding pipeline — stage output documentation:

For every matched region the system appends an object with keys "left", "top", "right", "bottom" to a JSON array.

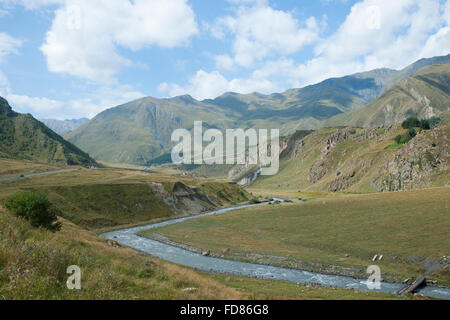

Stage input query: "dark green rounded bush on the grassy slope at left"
[{"left": 4, "top": 192, "right": 61, "bottom": 232}]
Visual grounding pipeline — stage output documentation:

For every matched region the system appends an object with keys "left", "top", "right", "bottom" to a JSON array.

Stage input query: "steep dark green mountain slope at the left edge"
[{"left": 0, "top": 97, "right": 95, "bottom": 165}]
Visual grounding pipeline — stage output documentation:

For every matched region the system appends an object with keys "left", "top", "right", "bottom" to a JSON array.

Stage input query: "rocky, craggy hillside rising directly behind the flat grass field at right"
[{"left": 252, "top": 123, "right": 450, "bottom": 193}]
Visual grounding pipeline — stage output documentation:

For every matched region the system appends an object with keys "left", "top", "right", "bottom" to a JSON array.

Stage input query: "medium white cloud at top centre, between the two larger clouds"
[{"left": 211, "top": 1, "right": 320, "bottom": 67}]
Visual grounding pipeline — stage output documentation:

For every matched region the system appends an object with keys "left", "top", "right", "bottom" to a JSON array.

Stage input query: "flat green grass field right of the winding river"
[{"left": 149, "top": 188, "right": 450, "bottom": 285}]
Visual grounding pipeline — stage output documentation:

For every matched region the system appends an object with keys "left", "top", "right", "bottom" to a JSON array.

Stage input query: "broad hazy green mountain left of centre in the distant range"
[{"left": 65, "top": 96, "right": 235, "bottom": 165}]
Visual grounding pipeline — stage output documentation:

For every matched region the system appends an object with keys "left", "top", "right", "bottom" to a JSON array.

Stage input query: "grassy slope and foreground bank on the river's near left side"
[{"left": 0, "top": 160, "right": 414, "bottom": 299}]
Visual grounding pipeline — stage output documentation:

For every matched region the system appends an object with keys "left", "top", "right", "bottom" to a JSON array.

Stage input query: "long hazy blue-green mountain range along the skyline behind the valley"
[{"left": 64, "top": 55, "right": 450, "bottom": 165}]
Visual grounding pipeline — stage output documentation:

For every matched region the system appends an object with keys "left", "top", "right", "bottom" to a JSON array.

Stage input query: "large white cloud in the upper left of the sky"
[{"left": 35, "top": 0, "right": 198, "bottom": 83}]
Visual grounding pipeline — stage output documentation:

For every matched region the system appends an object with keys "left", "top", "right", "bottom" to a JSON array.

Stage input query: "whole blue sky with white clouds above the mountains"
[{"left": 0, "top": 0, "right": 450, "bottom": 119}]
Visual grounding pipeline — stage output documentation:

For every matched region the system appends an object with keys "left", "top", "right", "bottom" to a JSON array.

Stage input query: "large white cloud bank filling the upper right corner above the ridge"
[{"left": 253, "top": 0, "right": 450, "bottom": 87}]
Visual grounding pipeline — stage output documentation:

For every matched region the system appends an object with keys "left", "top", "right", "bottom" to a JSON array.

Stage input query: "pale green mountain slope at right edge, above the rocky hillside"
[{"left": 324, "top": 64, "right": 450, "bottom": 127}]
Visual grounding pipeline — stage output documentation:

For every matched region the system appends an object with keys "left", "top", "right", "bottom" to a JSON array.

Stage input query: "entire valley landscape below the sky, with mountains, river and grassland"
[{"left": 0, "top": 56, "right": 450, "bottom": 299}]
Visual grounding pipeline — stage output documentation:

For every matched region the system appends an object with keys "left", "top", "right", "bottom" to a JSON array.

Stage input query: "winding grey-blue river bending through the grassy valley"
[{"left": 101, "top": 199, "right": 450, "bottom": 300}]
